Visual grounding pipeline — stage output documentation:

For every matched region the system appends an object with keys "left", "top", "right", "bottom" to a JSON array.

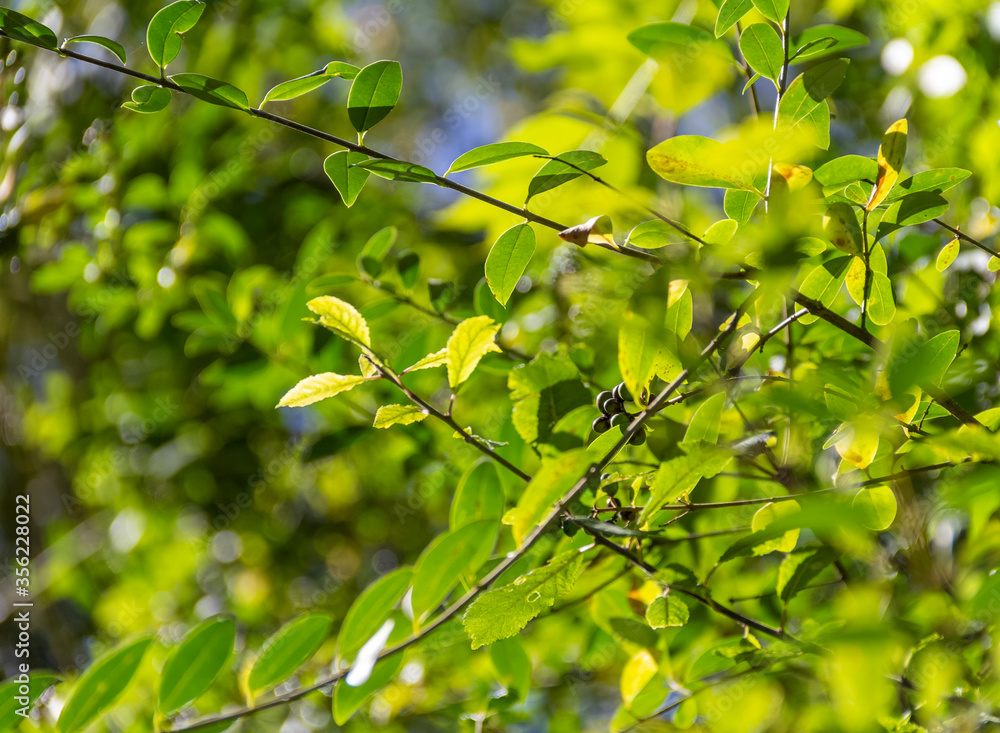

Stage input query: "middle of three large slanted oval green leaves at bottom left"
[{"left": 157, "top": 616, "right": 236, "bottom": 715}]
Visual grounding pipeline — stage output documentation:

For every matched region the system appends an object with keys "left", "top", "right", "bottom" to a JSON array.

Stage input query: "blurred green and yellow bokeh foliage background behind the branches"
[{"left": 0, "top": 0, "right": 1000, "bottom": 731}]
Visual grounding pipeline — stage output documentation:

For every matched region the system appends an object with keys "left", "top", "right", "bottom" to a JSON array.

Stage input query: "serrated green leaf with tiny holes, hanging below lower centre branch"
[{"left": 462, "top": 550, "right": 583, "bottom": 649}]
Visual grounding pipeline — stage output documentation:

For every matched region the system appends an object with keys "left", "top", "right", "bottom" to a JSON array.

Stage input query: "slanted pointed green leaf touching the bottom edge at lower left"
[{"left": 56, "top": 636, "right": 153, "bottom": 733}]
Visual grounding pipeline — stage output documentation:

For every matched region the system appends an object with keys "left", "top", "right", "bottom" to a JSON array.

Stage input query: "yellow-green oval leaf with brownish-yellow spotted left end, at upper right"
[{"left": 646, "top": 135, "right": 756, "bottom": 191}]
